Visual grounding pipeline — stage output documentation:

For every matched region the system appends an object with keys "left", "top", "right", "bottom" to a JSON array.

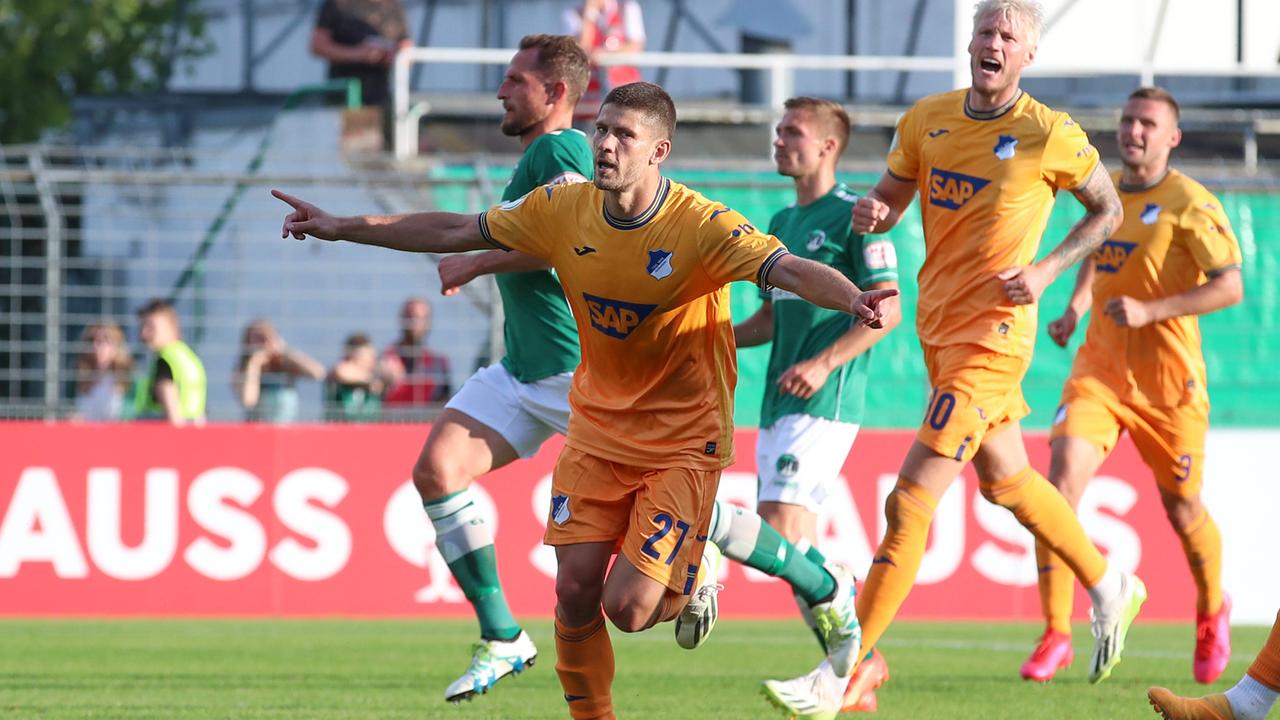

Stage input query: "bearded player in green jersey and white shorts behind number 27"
[{"left": 389, "top": 35, "right": 591, "bottom": 702}]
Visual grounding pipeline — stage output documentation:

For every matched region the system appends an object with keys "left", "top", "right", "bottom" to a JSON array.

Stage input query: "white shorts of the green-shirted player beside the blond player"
[{"left": 755, "top": 415, "right": 858, "bottom": 512}]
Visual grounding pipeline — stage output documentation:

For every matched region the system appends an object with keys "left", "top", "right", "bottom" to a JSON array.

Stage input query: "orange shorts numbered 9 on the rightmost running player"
[{"left": 1050, "top": 375, "right": 1208, "bottom": 497}]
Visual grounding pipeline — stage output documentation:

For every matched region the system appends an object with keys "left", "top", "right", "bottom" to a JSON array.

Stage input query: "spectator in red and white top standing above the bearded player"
[{"left": 563, "top": 0, "right": 645, "bottom": 120}]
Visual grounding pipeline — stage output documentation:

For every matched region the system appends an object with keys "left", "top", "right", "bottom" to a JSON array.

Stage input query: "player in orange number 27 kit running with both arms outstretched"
[{"left": 273, "top": 83, "right": 895, "bottom": 719}]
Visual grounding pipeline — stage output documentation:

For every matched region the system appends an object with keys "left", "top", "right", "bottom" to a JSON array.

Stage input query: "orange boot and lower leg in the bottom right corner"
[{"left": 1147, "top": 604, "right": 1280, "bottom": 720}]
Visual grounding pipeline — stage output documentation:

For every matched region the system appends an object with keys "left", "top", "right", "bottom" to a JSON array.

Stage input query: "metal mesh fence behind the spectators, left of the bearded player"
[{"left": 0, "top": 137, "right": 502, "bottom": 420}]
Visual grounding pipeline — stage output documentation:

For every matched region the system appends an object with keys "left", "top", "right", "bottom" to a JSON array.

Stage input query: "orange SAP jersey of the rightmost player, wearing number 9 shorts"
[{"left": 1071, "top": 170, "right": 1240, "bottom": 407}]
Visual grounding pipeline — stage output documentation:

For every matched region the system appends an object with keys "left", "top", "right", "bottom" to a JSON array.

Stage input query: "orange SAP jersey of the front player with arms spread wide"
[{"left": 480, "top": 178, "right": 786, "bottom": 470}]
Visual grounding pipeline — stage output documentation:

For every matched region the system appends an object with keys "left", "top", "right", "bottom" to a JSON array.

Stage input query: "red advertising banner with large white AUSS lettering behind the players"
[{"left": 0, "top": 423, "right": 1231, "bottom": 620}]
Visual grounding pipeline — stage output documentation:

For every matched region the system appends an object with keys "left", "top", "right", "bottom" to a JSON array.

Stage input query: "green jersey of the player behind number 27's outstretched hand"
[{"left": 760, "top": 183, "right": 897, "bottom": 428}]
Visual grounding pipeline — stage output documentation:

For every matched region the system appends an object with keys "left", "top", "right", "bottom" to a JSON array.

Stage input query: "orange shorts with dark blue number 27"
[{"left": 543, "top": 447, "right": 721, "bottom": 594}]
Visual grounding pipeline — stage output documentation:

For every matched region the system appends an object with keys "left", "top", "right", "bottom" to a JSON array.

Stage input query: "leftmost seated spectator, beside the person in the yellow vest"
[{"left": 73, "top": 322, "right": 133, "bottom": 423}]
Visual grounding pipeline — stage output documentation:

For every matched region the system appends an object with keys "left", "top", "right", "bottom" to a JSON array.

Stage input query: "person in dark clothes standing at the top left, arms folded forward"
[{"left": 311, "top": 0, "right": 412, "bottom": 108}]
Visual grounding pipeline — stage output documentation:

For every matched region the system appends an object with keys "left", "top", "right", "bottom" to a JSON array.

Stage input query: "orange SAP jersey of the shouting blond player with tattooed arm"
[{"left": 888, "top": 90, "right": 1098, "bottom": 355}]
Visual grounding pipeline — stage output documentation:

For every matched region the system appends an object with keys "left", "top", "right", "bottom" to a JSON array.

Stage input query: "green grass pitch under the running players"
[{"left": 0, "top": 618, "right": 1280, "bottom": 720}]
